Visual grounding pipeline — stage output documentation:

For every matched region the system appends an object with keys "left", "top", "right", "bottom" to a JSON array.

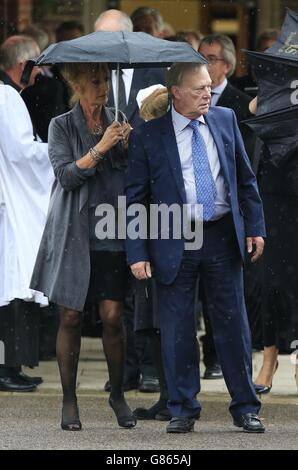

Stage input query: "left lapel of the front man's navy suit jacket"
[{"left": 161, "top": 110, "right": 186, "bottom": 204}]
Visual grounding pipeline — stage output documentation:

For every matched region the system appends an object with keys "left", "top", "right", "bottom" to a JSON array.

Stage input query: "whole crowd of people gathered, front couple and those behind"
[{"left": 0, "top": 7, "right": 298, "bottom": 433}]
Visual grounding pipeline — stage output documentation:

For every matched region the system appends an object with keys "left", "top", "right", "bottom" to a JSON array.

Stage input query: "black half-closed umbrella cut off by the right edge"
[{"left": 245, "top": 10, "right": 298, "bottom": 166}]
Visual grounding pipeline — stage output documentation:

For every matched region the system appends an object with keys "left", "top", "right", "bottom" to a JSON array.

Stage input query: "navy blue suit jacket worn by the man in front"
[{"left": 126, "top": 106, "right": 265, "bottom": 284}]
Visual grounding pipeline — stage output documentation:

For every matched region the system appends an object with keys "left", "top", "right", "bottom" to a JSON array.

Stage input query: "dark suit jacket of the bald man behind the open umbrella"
[{"left": 108, "top": 68, "right": 165, "bottom": 127}]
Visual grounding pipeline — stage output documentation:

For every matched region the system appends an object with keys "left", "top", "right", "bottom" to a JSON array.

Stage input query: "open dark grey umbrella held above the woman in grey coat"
[{"left": 29, "top": 31, "right": 207, "bottom": 119}]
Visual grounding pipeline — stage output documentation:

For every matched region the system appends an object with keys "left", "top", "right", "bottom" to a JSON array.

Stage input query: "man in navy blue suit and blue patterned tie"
[{"left": 126, "top": 64, "right": 265, "bottom": 433}]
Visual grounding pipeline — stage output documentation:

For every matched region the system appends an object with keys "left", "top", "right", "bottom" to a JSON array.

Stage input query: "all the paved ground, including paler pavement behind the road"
[{"left": 0, "top": 339, "right": 298, "bottom": 450}]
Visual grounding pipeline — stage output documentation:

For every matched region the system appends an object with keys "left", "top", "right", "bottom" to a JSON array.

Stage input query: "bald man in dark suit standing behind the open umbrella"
[{"left": 94, "top": 9, "right": 165, "bottom": 392}]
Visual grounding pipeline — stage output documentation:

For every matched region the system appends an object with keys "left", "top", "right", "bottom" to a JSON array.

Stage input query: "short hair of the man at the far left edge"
[{"left": 0, "top": 35, "right": 40, "bottom": 70}]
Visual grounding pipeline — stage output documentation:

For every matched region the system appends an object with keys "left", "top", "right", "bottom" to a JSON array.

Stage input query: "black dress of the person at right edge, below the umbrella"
[{"left": 259, "top": 149, "right": 298, "bottom": 352}]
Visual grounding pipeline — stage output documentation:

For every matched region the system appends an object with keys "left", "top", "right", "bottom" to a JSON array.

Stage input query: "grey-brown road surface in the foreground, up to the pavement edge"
[{"left": 0, "top": 392, "right": 298, "bottom": 450}]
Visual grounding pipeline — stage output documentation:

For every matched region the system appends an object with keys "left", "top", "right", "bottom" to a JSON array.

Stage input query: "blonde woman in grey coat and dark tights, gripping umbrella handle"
[{"left": 31, "top": 64, "right": 136, "bottom": 431}]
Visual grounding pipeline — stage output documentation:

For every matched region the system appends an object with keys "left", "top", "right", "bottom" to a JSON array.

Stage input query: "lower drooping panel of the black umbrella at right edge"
[{"left": 244, "top": 105, "right": 298, "bottom": 167}]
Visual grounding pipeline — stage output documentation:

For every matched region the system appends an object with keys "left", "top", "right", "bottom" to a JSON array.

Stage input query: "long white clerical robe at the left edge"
[{"left": 0, "top": 84, "right": 54, "bottom": 307}]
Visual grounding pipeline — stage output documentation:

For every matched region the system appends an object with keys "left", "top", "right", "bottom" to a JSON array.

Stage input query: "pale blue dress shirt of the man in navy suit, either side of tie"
[{"left": 172, "top": 106, "right": 230, "bottom": 220}]
